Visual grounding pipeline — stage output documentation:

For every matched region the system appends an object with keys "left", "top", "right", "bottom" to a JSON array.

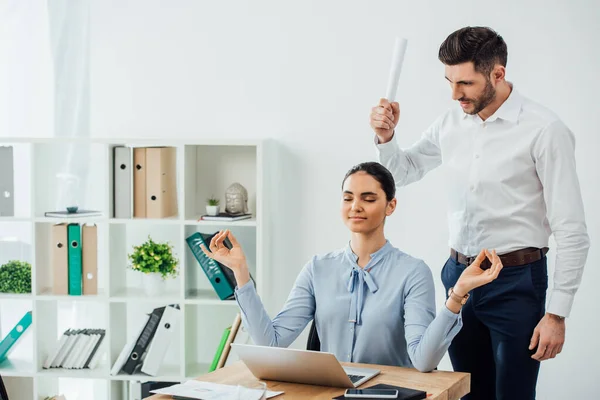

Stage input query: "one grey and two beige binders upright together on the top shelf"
[{"left": 113, "top": 146, "right": 177, "bottom": 218}]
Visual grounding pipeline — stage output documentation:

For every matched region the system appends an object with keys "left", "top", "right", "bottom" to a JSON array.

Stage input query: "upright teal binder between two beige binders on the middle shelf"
[{"left": 51, "top": 223, "right": 98, "bottom": 296}]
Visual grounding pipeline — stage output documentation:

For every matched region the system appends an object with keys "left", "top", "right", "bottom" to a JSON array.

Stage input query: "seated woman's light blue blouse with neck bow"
[{"left": 235, "top": 242, "right": 462, "bottom": 371}]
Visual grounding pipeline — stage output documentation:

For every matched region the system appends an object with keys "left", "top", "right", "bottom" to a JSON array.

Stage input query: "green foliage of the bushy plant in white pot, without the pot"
[{"left": 127, "top": 235, "right": 179, "bottom": 279}]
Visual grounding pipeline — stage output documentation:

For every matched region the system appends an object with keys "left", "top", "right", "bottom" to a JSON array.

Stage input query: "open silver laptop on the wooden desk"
[{"left": 231, "top": 343, "right": 381, "bottom": 388}]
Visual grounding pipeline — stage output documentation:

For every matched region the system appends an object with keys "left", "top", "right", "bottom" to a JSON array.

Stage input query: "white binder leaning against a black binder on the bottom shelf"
[{"left": 142, "top": 305, "right": 181, "bottom": 376}]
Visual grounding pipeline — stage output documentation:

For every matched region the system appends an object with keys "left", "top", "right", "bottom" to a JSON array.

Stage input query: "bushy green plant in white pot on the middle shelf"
[{"left": 128, "top": 235, "right": 179, "bottom": 296}]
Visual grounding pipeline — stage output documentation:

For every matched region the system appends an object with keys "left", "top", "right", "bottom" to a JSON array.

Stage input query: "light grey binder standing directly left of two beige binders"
[{"left": 113, "top": 146, "right": 132, "bottom": 218}]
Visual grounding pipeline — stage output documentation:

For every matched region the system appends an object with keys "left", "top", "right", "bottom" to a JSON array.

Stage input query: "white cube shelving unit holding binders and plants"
[{"left": 0, "top": 138, "right": 270, "bottom": 400}]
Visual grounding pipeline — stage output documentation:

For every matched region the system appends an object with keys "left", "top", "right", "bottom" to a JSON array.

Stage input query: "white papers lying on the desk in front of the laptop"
[{"left": 150, "top": 380, "right": 283, "bottom": 400}]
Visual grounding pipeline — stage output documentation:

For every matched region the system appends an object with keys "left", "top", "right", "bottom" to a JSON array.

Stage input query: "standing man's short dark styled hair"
[{"left": 438, "top": 26, "right": 508, "bottom": 76}]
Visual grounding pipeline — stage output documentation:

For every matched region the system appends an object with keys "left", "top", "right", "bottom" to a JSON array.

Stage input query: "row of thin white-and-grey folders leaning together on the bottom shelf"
[{"left": 43, "top": 329, "right": 106, "bottom": 369}]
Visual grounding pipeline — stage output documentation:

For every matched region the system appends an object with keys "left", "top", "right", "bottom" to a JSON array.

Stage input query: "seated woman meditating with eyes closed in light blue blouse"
[{"left": 202, "top": 162, "right": 502, "bottom": 372}]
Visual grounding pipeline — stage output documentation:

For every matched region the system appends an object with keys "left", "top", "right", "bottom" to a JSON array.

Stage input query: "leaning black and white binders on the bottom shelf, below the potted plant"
[{"left": 110, "top": 304, "right": 181, "bottom": 376}]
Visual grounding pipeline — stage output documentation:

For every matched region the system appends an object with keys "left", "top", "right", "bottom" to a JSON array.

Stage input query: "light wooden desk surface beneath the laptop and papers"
[{"left": 146, "top": 361, "right": 471, "bottom": 400}]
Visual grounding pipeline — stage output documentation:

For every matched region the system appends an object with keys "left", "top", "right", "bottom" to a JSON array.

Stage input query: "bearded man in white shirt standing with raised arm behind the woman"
[{"left": 370, "top": 27, "right": 589, "bottom": 400}]
